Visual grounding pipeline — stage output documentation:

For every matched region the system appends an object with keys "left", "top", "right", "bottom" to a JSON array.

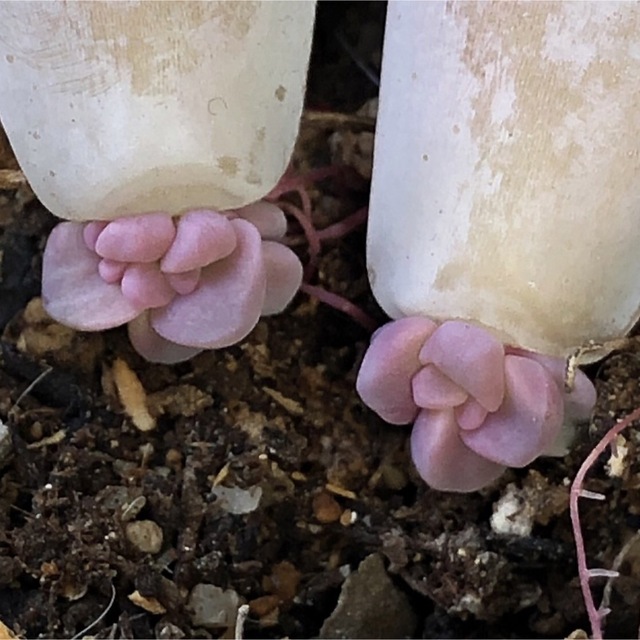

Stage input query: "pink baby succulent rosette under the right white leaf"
[{"left": 357, "top": 317, "right": 596, "bottom": 491}]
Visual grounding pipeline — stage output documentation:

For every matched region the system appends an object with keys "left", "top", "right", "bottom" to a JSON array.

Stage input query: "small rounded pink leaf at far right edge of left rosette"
[{"left": 261, "top": 240, "right": 303, "bottom": 316}]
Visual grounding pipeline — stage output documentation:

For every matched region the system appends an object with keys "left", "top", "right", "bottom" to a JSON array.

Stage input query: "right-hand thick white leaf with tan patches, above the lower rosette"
[{"left": 368, "top": 0, "right": 640, "bottom": 357}]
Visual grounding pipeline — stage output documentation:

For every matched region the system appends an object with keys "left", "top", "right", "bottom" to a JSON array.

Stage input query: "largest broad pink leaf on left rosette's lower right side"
[{"left": 150, "top": 219, "right": 266, "bottom": 349}]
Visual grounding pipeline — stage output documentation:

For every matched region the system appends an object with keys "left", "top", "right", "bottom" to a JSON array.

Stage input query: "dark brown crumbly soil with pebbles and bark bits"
[{"left": 0, "top": 2, "right": 640, "bottom": 638}]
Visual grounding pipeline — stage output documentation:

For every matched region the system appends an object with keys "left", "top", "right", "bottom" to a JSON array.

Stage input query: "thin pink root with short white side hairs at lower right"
[{"left": 569, "top": 407, "right": 640, "bottom": 640}]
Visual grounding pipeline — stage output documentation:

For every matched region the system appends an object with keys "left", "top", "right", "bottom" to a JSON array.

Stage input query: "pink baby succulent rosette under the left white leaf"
[{"left": 42, "top": 202, "right": 302, "bottom": 363}]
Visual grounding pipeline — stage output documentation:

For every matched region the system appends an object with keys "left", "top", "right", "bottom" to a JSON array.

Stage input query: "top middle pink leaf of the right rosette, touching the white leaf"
[{"left": 419, "top": 320, "right": 504, "bottom": 411}]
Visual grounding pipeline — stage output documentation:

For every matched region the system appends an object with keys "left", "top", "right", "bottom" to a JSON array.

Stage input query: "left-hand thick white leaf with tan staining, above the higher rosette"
[{"left": 0, "top": 0, "right": 315, "bottom": 220}]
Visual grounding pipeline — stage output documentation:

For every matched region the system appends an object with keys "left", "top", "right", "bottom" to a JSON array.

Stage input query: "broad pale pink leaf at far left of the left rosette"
[{"left": 42, "top": 222, "right": 142, "bottom": 331}]
